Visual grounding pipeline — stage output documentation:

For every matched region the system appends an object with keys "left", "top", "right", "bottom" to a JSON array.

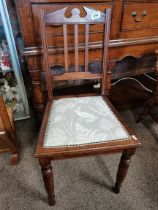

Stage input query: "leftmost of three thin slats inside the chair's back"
[{"left": 63, "top": 24, "right": 69, "bottom": 72}]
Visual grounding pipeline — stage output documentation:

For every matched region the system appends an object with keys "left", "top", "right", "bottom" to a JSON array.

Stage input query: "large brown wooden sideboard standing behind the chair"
[{"left": 15, "top": 0, "right": 158, "bottom": 118}]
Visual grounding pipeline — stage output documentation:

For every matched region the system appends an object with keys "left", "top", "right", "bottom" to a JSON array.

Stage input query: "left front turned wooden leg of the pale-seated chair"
[{"left": 39, "top": 158, "right": 55, "bottom": 206}]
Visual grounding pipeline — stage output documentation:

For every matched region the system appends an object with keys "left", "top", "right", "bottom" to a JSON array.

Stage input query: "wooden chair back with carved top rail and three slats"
[{"left": 40, "top": 7, "right": 111, "bottom": 100}]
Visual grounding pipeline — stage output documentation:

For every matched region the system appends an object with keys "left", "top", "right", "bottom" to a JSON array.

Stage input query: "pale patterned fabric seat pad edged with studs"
[{"left": 44, "top": 96, "right": 130, "bottom": 147}]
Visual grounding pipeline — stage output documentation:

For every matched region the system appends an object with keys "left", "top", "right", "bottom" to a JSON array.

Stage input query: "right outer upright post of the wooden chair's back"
[{"left": 101, "top": 9, "right": 111, "bottom": 95}]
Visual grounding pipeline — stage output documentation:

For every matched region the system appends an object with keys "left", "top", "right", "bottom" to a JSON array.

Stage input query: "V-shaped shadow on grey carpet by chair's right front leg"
[{"left": 80, "top": 156, "right": 115, "bottom": 192}]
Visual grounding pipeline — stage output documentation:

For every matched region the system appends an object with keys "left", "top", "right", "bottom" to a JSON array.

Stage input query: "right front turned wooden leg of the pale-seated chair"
[{"left": 114, "top": 149, "right": 135, "bottom": 193}]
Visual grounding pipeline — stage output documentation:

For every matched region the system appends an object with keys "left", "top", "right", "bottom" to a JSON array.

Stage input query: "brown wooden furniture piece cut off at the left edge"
[{"left": 0, "top": 96, "right": 19, "bottom": 165}]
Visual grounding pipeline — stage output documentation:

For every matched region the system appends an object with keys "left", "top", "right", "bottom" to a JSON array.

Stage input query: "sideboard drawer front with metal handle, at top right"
[{"left": 121, "top": 2, "right": 158, "bottom": 31}]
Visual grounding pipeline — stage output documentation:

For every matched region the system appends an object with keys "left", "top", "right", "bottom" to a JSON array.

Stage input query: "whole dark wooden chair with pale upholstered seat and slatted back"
[{"left": 35, "top": 7, "right": 140, "bottom": 205}]
